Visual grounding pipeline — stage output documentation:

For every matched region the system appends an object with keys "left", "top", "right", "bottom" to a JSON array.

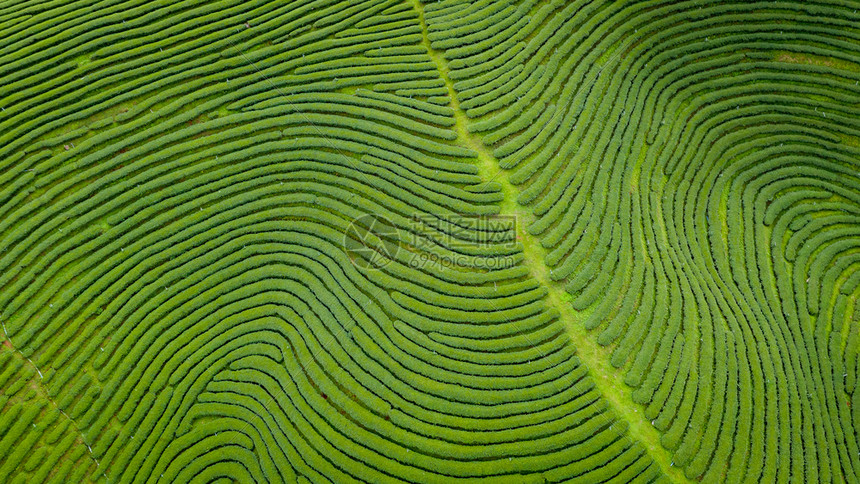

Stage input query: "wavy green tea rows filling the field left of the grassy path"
[{"left": 0, "top": 0, "right": 672, "bottom": 483}]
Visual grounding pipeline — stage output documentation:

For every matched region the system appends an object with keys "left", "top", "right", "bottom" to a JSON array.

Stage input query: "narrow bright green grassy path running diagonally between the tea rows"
[{"left": 410, "top": 0, "right": 691, "bottom": 482}]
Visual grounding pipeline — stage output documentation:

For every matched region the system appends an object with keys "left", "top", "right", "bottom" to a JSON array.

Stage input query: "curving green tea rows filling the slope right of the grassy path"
[{"left": 427, "top": 0, "right": 860, "bottom": 482}]
